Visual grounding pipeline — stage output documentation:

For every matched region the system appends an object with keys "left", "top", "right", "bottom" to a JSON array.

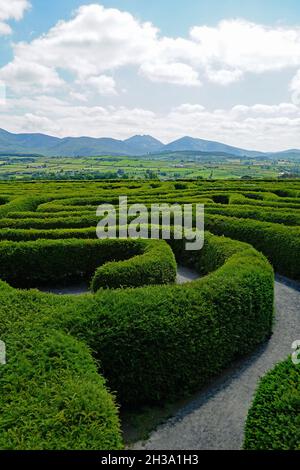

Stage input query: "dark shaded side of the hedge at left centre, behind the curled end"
[{"left": 0, "top": 239, "right": 144, "bottom": 287}]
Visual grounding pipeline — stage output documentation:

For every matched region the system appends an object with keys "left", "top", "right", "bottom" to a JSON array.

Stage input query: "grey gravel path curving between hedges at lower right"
[{"left": 133, "top": 268, "right": 300, "bottom": 450}]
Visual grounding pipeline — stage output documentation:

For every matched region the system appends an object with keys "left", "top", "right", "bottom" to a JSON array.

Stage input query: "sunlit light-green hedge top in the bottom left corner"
[{"left": 0, "top": 290, "right": 123, "bottom": 451}]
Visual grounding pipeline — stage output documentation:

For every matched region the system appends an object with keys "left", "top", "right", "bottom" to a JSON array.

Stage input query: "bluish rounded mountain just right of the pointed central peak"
[{"left": 164, "top": 137, "right": 263, "bottom": 157}]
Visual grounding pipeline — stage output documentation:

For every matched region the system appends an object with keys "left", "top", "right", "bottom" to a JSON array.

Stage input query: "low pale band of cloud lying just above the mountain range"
[{"left": 0, "top": 95, "right": 300, "bottom": 151}]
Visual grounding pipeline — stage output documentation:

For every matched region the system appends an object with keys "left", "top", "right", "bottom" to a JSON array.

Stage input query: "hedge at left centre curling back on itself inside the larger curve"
[{"left": 0, "top": 239, "right": 176, "bottom": 290}]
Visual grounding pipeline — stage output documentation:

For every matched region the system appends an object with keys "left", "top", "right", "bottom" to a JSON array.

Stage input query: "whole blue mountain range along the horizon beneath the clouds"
[{"left": 0, "top": 129, "right": 300, "bottom": 158}]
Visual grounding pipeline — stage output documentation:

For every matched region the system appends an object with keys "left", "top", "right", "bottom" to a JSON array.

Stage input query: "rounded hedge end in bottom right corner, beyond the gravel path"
[{"left": 244, "top": 358, "right": 300, "bottom": 450}]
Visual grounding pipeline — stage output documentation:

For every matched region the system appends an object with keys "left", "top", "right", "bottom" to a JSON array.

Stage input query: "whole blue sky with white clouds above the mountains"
[{"left": 0, "top": 0, "right": 300, "bottom": 151}]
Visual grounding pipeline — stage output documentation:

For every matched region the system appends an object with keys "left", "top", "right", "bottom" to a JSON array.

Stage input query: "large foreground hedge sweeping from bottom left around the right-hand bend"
[{"left": 0, "top": 234, "right": 273, "bottom": 449}]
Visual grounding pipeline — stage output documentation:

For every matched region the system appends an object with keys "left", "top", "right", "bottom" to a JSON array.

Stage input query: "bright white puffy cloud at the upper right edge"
[{"left": 190, "top": 19, "right": 300, "bottom": 73}]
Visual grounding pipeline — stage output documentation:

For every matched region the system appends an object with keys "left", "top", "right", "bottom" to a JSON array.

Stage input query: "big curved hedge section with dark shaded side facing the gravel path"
[{"left": 55, "top": 234, "right": 274, "bottom": 406}]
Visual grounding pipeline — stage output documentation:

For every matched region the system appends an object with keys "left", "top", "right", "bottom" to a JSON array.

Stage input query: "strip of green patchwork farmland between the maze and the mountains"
[{"left": 0, "top": 152, "right": 300, "bottom": 180}]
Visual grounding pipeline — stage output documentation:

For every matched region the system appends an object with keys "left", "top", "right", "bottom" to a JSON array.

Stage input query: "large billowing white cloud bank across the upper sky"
[{"left": 0, "top": 5, "right": 300, "bottom": 94}]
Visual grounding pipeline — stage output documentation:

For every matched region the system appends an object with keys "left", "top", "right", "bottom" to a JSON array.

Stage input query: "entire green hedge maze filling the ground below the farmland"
[{"left": 0, "top": 181, "right": 300, "bottom": 450}]
